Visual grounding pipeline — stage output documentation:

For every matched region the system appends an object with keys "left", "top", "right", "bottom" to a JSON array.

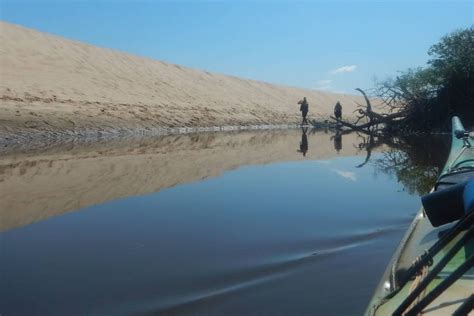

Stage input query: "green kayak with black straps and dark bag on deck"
[{"left": 365, "top": 117, "right": 474, "bottom": 316}]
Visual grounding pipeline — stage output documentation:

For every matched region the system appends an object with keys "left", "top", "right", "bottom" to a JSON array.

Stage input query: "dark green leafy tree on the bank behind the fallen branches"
[{"left": 376, "top": 26, "right": 474, "bottom": 132}]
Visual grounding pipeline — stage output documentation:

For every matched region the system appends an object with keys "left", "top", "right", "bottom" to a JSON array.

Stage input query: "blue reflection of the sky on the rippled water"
[{"left": 0, "top": 155, "right": 419, "bottom": 314}]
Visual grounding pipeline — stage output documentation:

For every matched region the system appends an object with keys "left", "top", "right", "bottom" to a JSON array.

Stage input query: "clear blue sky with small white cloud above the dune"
[{"left": 0, "top": 0, "right": 474, "bottom": 93}]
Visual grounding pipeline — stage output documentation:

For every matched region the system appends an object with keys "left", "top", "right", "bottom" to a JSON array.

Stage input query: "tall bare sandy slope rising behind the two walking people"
[{"left": 0, "top": 22, "right": 370, "bottom": 138}]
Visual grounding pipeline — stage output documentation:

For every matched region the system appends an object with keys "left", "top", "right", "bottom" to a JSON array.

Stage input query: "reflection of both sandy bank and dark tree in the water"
[{"left": 0, "top": 127, "right": 449, "bottom": 231}]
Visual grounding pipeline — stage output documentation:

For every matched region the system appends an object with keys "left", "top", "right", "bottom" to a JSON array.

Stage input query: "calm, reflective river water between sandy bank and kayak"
[{"left": 0, "top": 130, "right": 448, "bottom": 315}]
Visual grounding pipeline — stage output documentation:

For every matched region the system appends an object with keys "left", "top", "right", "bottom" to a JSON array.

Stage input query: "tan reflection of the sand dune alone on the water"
[{"left": 0, "top": 130, "right": 382, "bottom": 231}]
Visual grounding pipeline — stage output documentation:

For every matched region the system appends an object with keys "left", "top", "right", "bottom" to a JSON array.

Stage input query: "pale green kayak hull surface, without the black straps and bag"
[{"left": 365, "top": 117, "right": 474, "bottom": 316}]
